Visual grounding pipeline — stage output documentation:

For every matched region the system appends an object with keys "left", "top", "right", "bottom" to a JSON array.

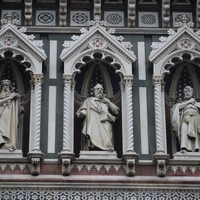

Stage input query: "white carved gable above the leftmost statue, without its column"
[{"left": 0, "top": 14, "right": 46, "bottom": 74}]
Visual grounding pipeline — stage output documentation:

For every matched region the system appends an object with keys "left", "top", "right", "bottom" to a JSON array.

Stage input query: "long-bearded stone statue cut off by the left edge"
[{"left": 0, "top": 80, "right": 20, "bottom": 152}]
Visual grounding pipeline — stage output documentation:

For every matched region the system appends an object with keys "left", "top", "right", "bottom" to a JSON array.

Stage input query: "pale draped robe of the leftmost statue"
[{"left": 0, "top": 97, "right": 18, "bottom": 149}]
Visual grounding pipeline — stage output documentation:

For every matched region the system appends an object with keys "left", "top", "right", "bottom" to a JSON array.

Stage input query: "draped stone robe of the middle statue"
[{"left": 76, "top": 97, "right": 115, "bottom": 150}]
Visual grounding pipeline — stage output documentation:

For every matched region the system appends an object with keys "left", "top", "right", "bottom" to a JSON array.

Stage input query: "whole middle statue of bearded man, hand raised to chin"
[{"left": 76, "top": 84, "right": 119, "bottom": 152}]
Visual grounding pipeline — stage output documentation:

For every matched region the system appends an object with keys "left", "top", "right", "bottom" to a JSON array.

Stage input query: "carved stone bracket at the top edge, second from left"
[{"left": 59, "top": 0, "right": 67, "bottom": 27}]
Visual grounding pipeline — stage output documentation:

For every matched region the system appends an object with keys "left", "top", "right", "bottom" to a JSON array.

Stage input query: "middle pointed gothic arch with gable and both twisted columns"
[{"left": 60, "top": 16, "right": 136, "bottom": 161}]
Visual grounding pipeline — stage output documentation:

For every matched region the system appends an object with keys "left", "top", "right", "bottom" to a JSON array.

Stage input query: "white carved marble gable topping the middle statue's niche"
[{"left": 60, "top": 16, "right": 136, "bottom": 74}]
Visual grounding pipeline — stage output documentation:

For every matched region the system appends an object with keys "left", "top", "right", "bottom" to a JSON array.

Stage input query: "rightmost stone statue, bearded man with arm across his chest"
[{"left": 171, "top": 86, "right": 200, "bottom": 153}]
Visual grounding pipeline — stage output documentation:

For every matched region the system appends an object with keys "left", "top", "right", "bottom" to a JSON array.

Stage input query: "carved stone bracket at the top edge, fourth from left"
[{"left": 128, "top": 0, "right": 136, "bottom": 28}]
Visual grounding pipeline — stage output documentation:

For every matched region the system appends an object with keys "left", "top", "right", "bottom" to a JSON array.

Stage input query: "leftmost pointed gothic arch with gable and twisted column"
[{"left": 0, "top": 14, "right": 46, "bottom": 159}]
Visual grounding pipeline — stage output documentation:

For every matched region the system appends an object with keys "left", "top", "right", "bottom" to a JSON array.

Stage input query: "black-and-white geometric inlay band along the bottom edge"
[{"left": 0, "top": 188, "right": 199, "bottom": 200}]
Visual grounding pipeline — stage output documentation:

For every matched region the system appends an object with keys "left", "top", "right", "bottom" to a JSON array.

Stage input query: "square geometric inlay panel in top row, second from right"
[{"left": 139, "top": 12, "right": 159, "bottom": 27}]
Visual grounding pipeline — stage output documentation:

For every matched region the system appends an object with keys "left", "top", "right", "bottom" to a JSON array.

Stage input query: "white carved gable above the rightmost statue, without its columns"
[{"left": 149, "top": 16, "right": 200, "bottom": 75}]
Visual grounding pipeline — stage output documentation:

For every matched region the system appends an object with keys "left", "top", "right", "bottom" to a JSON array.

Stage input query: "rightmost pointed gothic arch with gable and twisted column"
[{"left": 149, "top": 16, "right": 200, "bottom": 158}]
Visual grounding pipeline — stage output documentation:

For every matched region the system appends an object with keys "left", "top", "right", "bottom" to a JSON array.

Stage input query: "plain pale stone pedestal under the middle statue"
[{"left": 79, "top": 151, "right": 118, "bottom": 160}]
